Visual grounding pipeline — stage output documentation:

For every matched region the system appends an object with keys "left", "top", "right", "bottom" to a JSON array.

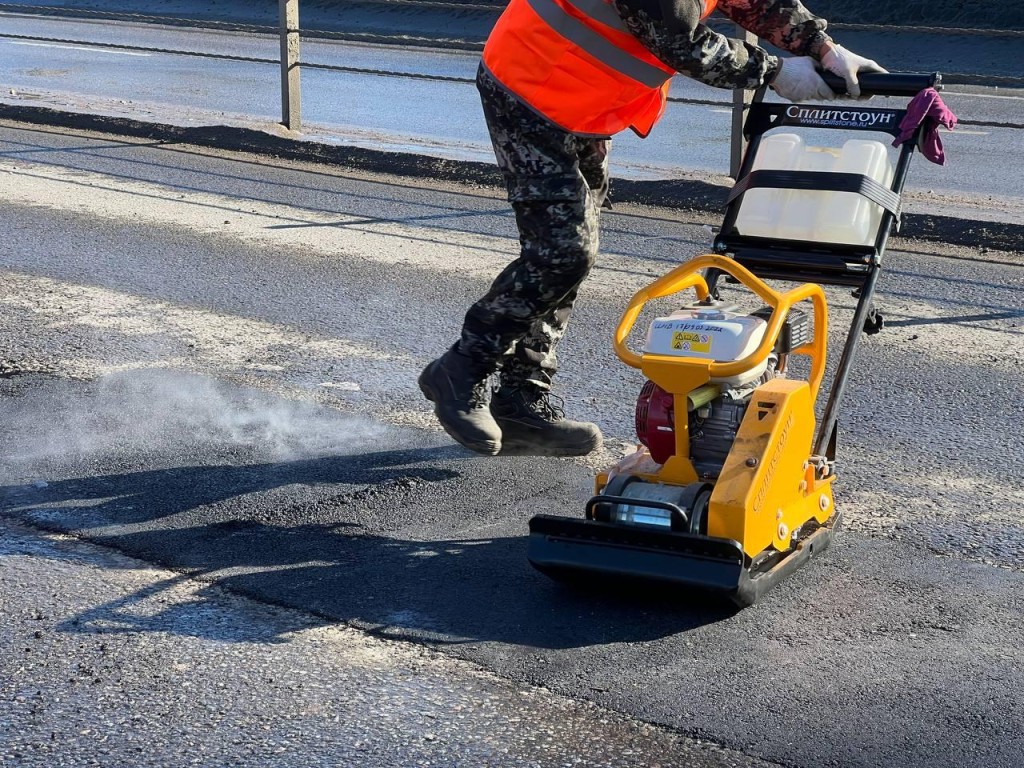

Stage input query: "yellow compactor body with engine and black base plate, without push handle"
[{"left": 529, "top": 255, "right": 837, "bottom": 605}]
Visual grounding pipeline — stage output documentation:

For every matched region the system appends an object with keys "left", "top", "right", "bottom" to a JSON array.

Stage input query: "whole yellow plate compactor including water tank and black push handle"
[{"left": 528, "top": 74, "right": 940, "bottom": 606}]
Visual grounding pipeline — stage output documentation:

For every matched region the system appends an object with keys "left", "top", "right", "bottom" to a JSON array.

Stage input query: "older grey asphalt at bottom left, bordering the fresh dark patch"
[{"left": 0, "top": 520, "right": 768, "bottom": 768}]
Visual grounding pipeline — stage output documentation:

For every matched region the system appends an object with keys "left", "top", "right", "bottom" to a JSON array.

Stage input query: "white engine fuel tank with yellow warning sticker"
[{"left": 643, "top": 307, "right": 768, "bottom": 386}]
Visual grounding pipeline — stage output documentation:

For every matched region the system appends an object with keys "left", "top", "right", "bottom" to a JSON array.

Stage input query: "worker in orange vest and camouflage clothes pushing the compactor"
[{"left": 419, "top": 0, "right": 885, "bottom": 456}]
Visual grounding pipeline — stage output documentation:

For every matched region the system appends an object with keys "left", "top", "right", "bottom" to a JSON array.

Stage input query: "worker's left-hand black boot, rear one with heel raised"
[{"left": 419, "top": 347, "right": 502, "bottom": 456}]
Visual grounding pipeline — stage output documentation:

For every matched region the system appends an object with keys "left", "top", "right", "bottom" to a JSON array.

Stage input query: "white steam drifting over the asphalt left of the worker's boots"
[{"left": 2, "top": 370, "right": 385, "bottom": 473}]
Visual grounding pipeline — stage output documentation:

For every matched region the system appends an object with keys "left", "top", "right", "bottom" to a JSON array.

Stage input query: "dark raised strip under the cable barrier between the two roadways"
[{"left": 0, "top": 103, "right": 1024, "bottom": 253}]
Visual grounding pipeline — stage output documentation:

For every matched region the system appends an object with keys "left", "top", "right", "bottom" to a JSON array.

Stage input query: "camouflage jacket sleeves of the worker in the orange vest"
[{"left": 612, "top": 0, "right": 827, "bottom": 88}]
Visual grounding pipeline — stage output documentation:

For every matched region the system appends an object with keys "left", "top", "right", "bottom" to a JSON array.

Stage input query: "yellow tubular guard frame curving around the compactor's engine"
[{"left": 615, "top": 254, "right": 828, "bottom": 399}]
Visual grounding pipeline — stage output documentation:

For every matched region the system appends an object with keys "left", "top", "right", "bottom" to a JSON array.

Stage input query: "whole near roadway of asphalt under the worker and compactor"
[{"left": 0, "top": 124, "right": 1024, "bottom": 768}]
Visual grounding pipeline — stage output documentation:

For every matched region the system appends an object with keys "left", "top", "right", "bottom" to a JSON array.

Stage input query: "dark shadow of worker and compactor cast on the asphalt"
[{"left": 0, "top": 446, "right": 732, "bottom": 648}]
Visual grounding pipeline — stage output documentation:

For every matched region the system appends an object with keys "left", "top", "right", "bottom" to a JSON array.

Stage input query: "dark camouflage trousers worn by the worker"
[{"left": 459, "top": 66, "right": 610, "bottom": 387}]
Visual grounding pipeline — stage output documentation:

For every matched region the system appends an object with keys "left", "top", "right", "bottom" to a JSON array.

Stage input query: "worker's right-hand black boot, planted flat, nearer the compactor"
[{"left": 490, "top": 383, "right": 601, "bottom": 456}]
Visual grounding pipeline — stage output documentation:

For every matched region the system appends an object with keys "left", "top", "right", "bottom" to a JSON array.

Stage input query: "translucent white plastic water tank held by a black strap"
[{"left": 736, "top": 133, "right": 893, "bottom": 245}]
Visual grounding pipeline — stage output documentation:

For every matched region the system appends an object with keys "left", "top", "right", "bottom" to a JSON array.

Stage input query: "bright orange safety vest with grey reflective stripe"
[{"left": 483, "top": 0, "right": 718, "bottom": 136}]
